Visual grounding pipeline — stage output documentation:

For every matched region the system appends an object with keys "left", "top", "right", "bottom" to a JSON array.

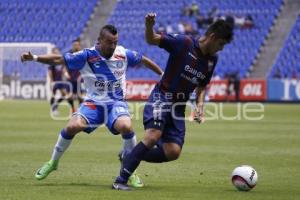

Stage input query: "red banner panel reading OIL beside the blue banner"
[{"left": 239, "top": 79, "right": 267, "bottom": 101}]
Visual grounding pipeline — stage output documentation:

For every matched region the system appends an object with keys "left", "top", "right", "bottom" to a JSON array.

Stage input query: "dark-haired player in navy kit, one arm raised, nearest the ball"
[{"left": 112, "top": 13, "right": 233, "bottom": 190}]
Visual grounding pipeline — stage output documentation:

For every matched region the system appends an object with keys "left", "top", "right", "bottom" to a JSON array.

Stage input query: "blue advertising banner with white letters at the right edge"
[{"left": 268, "top": 79, "right": 300, "bottom": 101}]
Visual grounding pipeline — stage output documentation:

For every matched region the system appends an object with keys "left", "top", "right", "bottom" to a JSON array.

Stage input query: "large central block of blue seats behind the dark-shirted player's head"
[{"left": 108, "top": 0, "right": 283, "bottom": 79}]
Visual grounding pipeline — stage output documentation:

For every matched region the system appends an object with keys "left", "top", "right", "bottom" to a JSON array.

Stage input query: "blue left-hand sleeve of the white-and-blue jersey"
[{"left": 64, "top": 49, "right": 87, "bottom": 70}]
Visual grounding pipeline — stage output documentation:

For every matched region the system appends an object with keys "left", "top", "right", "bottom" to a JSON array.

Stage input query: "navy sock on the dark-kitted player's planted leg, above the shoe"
[{"left": 116, "top": 142, "right": 149, "bottom": 183}]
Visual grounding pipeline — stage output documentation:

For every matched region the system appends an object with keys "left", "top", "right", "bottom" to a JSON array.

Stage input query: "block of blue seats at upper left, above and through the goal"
[{"left": 0, "top": 0, "right": 97, "bottom": 80}]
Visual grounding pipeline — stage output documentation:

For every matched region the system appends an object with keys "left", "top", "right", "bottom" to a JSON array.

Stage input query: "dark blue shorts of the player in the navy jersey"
[{"left": 143, "top": 87, "right": 185, "bottom": 147}]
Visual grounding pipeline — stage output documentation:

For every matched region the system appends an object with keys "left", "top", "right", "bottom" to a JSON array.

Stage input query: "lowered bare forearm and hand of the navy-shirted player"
[{"left": 194, "top": 87, "right": 205, "bottom": 124}]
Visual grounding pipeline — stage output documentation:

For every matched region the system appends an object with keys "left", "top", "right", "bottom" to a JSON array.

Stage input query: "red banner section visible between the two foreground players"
[{"left": 126, "top": 80, "right": 157, "bottom": 100}]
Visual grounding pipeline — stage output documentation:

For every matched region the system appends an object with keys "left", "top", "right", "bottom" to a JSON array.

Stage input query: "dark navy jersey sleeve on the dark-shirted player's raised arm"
[{"left": 159, "top": 34, "right": 189, "bottom": 54}]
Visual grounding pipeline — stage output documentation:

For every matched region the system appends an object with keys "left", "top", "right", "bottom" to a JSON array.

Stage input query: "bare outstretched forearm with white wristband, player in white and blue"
[{"left": 21, "top": 51, "right": 65, "bottom": 65}]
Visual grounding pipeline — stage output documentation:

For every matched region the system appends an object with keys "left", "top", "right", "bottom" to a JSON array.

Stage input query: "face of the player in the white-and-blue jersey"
[{"left": 99, "top": 31, "right": 118, "bottom": 59}]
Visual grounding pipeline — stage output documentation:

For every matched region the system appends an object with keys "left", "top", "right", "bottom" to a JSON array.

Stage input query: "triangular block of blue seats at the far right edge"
[{"left": 269, "top": 15, "right": 300, "bottom": 79}]
